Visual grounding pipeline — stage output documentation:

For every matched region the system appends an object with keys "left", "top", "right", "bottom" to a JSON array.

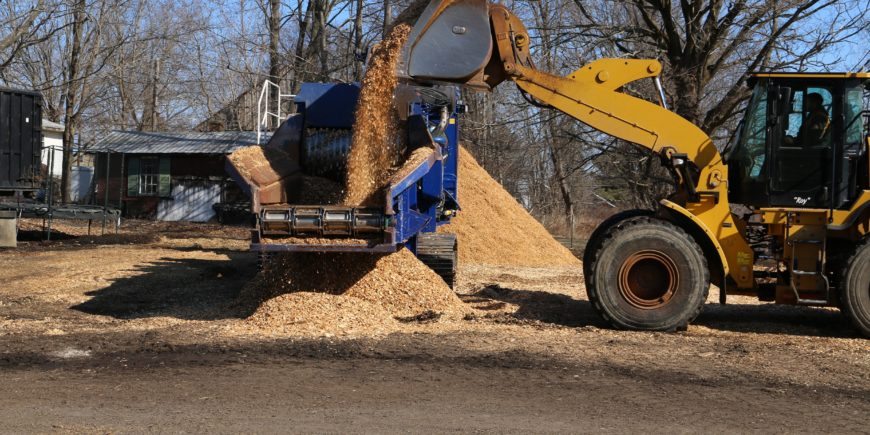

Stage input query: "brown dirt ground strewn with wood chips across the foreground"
[{"left": 0, "top": 221, "right": 870, "bottom": 433}]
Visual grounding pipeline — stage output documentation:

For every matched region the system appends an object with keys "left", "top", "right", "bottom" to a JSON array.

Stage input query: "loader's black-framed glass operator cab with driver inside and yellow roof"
[{"left": 726, "top": 73, "right": 870, "bottom": 209}]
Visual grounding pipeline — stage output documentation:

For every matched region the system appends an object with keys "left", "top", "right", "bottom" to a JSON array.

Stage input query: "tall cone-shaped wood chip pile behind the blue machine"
[{"left": 438, "top": 147, "right": 581, "bottom": 267}]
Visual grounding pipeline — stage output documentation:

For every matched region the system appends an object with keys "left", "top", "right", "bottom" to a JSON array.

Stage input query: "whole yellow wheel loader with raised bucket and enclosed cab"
[{"left": 399, "top": 0, "right": 870, "bottom": 336}]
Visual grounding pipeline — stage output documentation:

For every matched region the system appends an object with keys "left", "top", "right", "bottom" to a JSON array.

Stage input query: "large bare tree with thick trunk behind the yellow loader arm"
[{"left": 574, "top": 0, "right": 870, "bottom": 133}]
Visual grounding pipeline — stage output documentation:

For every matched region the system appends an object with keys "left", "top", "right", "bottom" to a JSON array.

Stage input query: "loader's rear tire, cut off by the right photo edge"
[{"left": 840, "top": 240, "right": 870, "bottom": 337}]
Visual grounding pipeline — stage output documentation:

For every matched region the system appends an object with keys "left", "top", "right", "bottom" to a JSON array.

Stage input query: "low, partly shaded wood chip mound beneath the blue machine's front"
[{"left": 240, "top": 249, "right": 469, "bottom": 333}]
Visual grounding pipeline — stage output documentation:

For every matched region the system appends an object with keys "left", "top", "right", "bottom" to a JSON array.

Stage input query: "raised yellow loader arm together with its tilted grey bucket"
[{"left": 400, "top": 0, "right": 754, "bottom": 288}]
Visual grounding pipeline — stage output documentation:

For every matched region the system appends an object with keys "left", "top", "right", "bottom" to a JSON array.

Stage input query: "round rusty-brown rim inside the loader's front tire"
[{"left": 619, "top": 250, "right": 679, "bottom": 310}]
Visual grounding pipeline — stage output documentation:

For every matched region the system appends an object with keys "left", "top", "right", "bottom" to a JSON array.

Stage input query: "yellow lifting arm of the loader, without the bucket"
[{"left": 509, "top": 59, "right": 754, "bottom": 288}]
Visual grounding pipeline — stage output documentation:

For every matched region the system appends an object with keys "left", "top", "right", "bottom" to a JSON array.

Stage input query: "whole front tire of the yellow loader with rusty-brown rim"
[{"left": 584, "top": 216, "right": 710, "bottom": 331}]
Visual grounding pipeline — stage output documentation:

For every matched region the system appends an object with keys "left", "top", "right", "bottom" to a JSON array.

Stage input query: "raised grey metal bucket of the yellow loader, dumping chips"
[{"left": 400, "top": 0, "right": 493, "bottom": 87}]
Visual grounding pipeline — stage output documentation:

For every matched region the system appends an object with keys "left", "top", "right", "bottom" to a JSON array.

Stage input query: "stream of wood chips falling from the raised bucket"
[{"left": 343, "top": 25, "right": 411, "bottom": 206}]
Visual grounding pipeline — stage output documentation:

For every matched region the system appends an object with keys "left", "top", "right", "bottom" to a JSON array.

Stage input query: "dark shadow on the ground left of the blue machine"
[{"left": 71, "top": 251, "right": 257, "bottom": 320}]
